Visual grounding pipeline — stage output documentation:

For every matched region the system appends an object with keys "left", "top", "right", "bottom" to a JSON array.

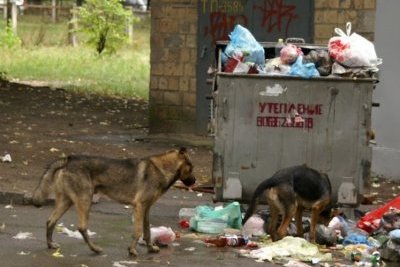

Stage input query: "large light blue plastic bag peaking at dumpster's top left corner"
[{"left": 222, "top": 24, "right": 265, "bottom": 66}]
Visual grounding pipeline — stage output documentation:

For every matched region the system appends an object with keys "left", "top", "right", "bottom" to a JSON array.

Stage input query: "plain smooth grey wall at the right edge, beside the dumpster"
[{"left": 372, "top": 0, "right": 400, "bottom": 180}]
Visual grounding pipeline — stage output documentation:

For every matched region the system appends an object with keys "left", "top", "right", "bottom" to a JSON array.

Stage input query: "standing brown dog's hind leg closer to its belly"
[{"left": 75, "top": 199, "right": 103, "bottom": 253}]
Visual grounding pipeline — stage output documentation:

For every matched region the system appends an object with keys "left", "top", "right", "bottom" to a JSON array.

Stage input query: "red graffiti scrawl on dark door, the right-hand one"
[{"left": 253, "top": 0, "right": 298, "bottom": 35}]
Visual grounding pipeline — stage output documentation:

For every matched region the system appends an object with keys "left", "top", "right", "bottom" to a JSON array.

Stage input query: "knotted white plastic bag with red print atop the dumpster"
[{"left": 328, "top": 22, "right": 382, "bottom": 69}]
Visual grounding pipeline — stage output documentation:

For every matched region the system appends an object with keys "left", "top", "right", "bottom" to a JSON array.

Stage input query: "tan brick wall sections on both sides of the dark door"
[{"left": 149, "top": 0, "right": 376, "bottom": 133}]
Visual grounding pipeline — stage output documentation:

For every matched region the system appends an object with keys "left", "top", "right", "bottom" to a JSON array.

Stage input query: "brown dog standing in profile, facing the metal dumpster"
[{"left": 32, "top": 148, "right": 196, "bottom": 256}]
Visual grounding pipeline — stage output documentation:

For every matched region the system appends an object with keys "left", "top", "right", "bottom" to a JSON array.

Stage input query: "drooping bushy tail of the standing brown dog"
[{"left": 32, "top": 158, "right": 67, "bottom": 207}]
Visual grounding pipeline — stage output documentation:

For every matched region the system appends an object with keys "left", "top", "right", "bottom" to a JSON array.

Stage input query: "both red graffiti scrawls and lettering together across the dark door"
[{"left": 200, "top": 0, "right": 299, "bottom": 42}]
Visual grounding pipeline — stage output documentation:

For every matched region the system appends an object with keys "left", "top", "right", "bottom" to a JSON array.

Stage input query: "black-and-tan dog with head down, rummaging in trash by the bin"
[{"left": 243, "top": 165, "right": 332, "bottom": 242}]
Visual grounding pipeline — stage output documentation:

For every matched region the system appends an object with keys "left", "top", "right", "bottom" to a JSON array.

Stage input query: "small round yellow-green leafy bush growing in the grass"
[{"left": 71, "top": 0, "right": 137, "bottom": 55}]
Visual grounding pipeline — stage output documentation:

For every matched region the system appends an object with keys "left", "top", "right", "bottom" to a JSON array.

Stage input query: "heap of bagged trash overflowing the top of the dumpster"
[{"left": 221, "top": 22, "right": 382, "bottom": 78}]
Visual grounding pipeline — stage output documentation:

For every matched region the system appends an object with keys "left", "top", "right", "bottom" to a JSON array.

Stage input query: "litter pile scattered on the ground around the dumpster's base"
[{"left": 171, "top": 197, "right": 400, "bottom": 266}]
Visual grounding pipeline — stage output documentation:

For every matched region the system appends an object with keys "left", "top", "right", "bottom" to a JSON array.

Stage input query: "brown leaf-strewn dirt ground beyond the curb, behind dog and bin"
[{"left": 0, "top": 81, "right": 400, "bottom": 204}]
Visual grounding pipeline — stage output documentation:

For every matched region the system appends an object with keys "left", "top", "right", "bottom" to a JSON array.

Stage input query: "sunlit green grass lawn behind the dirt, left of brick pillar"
[{"left": 0, "top": 12, "right": 150, "bottom": 99}]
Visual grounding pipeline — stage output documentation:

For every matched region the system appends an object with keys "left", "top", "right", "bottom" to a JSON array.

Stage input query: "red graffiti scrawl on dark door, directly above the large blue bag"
[{"left": 204, "top": 12, "right": 247, "bottom": 42}]
